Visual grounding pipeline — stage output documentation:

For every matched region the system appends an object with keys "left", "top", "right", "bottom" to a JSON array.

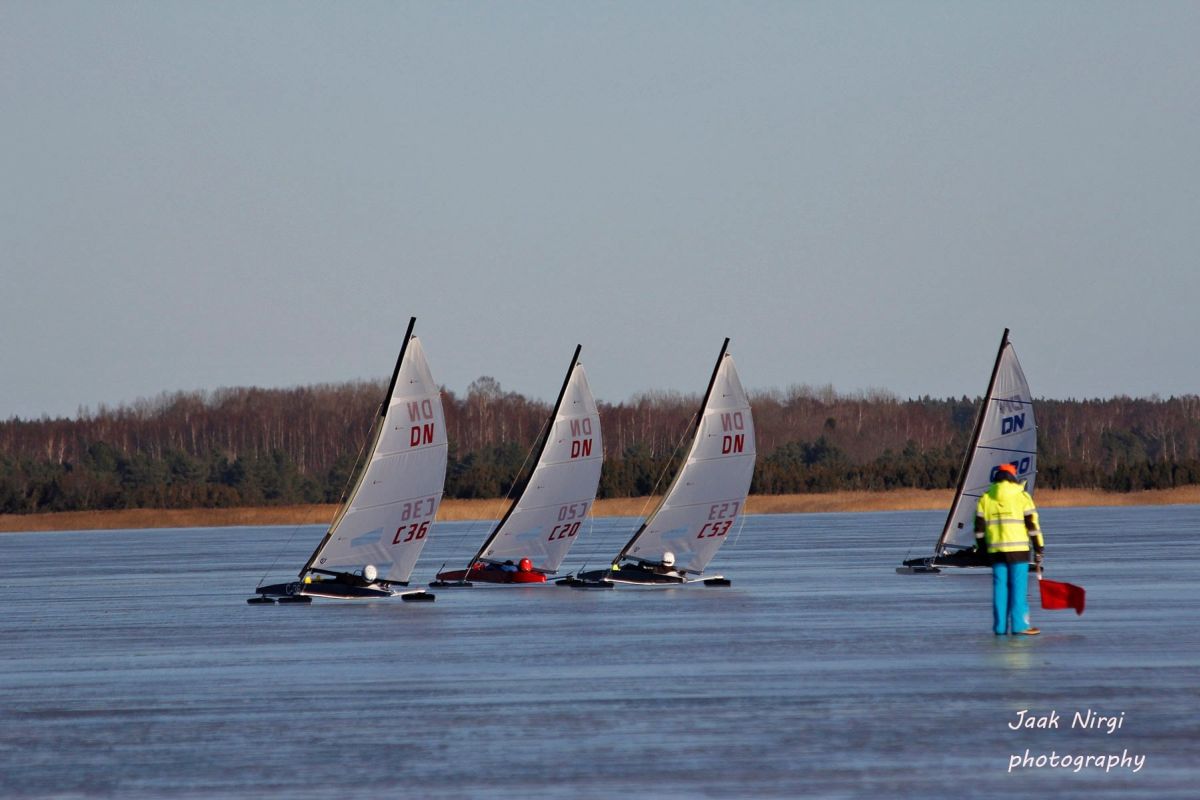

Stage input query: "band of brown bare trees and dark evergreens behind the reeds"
[{"left": 0, "top": 378, "right": 1200, "bottom": 513}]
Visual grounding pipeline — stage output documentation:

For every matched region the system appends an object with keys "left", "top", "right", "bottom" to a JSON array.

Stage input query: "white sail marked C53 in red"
[{"left": 622, "top": 353, "right": 755, "bottom": 573}]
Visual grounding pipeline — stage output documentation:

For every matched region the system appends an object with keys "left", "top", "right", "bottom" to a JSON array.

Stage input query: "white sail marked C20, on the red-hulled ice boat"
[{"left": 480, "top": 362, "right": 604, "bottom": 572}]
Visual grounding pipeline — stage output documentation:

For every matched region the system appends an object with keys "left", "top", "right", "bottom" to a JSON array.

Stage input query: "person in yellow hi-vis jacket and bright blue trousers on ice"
[{"left": 974, "top": 464, "right": 1045, "bottom": 636}]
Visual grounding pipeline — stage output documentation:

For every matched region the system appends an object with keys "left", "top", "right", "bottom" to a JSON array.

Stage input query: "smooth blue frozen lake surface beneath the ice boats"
[{"left": 0, "top": 506, "right": 1200, "bottom": 798}]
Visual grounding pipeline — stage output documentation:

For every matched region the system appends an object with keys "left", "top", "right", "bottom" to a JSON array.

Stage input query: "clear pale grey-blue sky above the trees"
[{"left": 0, "top": 0, "right": 1200, "bottom": 419}]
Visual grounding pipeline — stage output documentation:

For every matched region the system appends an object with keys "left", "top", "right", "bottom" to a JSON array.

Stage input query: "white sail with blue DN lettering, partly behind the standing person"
[{"left": 937, "top": 331, "right": 1038, "bottom": 552}]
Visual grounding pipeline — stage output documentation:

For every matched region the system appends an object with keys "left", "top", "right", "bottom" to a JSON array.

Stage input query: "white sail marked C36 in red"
[{"left": 311, "top": 336, "right": 449, "bottom": 583}]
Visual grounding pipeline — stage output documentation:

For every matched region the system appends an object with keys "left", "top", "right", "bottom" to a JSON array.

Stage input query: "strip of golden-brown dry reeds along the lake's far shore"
[{"left": 0, "top": 486, "right": 1200, "bottom": 533}]
